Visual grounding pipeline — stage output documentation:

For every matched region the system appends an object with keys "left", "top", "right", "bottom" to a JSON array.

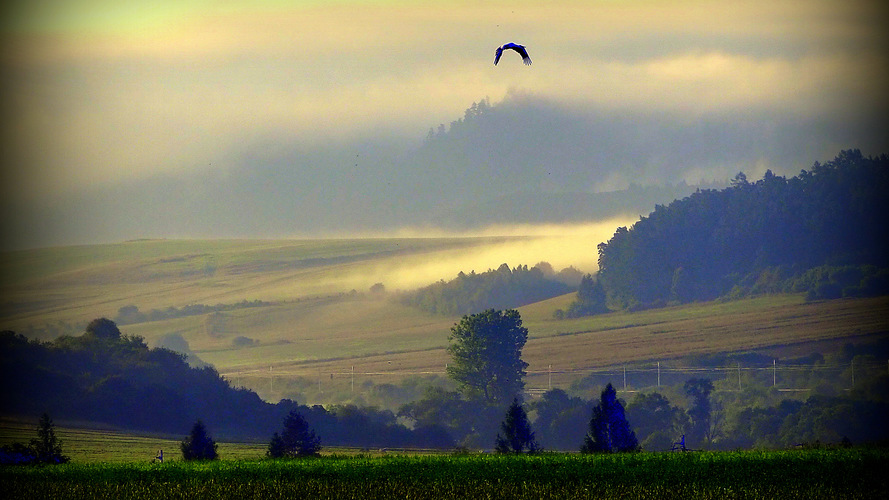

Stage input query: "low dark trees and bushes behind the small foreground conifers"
[{"left": 0, "top": 313, "right": 889, "bottom": 451}]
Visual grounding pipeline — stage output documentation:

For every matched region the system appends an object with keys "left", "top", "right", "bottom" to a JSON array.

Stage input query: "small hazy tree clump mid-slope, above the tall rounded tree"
[{"left": 402, "top": 264, "right": 572, "bottom": 315}]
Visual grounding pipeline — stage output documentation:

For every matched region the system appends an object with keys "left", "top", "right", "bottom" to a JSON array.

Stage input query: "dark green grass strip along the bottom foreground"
[{"left": 0, "top": 448, "right": 889, "bottom": 499}]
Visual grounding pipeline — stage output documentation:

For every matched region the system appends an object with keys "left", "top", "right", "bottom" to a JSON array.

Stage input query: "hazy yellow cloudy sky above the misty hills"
[{"left": 0, "top": 0, "right": 889, "bottom": 250}]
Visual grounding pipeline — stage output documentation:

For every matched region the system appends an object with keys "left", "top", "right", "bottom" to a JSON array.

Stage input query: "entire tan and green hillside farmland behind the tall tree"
[{"left": 0, "top": 237, "right": 889, "bottom": 401}]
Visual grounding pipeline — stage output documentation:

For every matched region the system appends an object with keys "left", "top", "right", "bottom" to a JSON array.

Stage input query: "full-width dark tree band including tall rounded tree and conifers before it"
[{"left": 0, "top": 309, "right": 889, "bottom": 456}]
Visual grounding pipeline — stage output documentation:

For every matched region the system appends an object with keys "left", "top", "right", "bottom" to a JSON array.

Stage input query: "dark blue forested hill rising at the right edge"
[{"left": 599, "top": 150, "right": 889, "bottom": 308}]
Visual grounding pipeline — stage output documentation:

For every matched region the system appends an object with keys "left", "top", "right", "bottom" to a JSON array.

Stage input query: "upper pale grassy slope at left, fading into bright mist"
[{"left": 0, "top": 237, "right": 526, "bottom": 330}]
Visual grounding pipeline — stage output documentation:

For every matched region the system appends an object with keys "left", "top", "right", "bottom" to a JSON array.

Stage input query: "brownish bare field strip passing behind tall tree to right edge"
[{"left": 221, "top": 297, "right": 889, "bottom": 380}]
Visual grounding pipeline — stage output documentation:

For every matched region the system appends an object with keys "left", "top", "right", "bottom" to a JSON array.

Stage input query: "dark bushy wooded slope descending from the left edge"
[{"left": 0, "top": 319, "right": 451, "bottom": 447}]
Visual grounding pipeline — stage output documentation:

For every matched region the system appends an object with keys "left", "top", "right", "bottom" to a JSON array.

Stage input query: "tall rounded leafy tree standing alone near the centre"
[{"left": 447, "top": 309, "right": 528, "bottom": 402}]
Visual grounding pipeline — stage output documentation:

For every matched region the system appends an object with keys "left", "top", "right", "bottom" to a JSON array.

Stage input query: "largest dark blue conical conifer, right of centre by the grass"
[{"left": 580, "top": 384, "right": 639, "bottom": 453}]
